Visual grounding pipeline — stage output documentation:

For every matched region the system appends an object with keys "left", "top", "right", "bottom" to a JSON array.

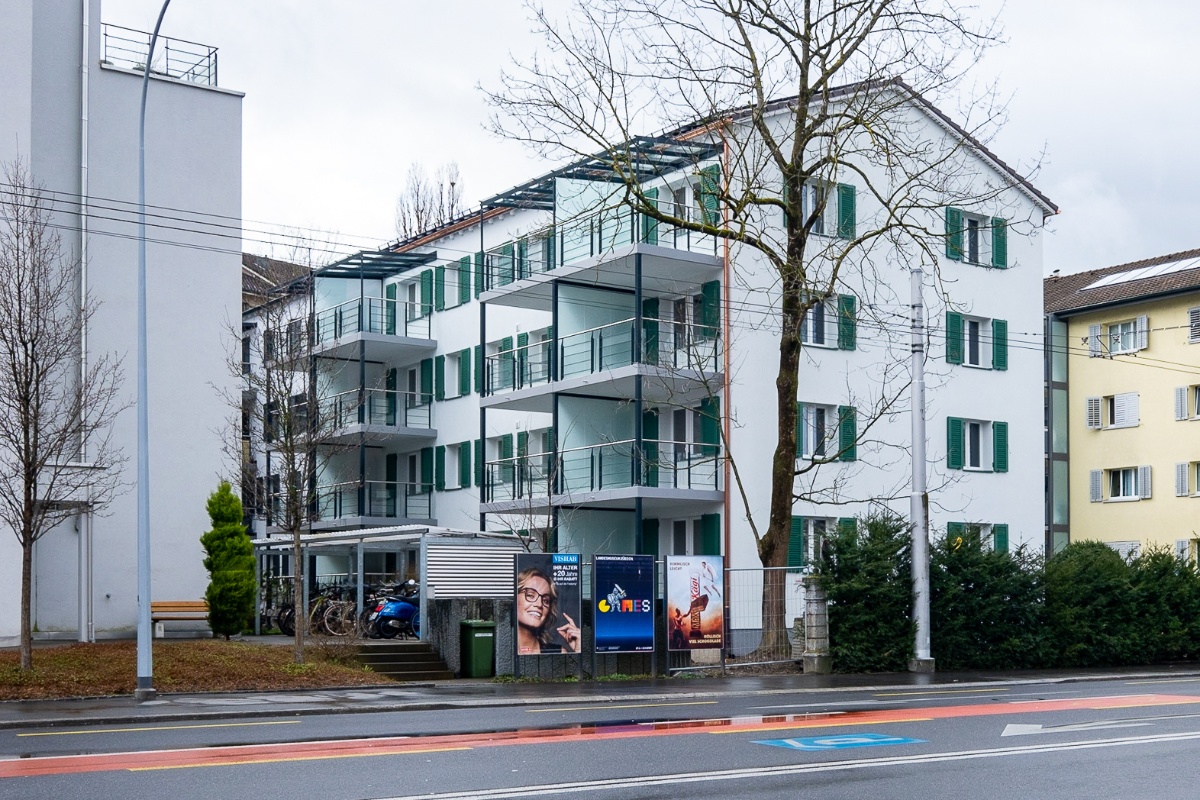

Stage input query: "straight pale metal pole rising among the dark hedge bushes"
[{"left": 908, "top": 267, "right": 934, "bottom": 673}]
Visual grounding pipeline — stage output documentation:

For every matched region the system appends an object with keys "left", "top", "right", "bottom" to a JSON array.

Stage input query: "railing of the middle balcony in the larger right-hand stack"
[{"left": 486, "top": 319, "right": 720, "bottom": 395}]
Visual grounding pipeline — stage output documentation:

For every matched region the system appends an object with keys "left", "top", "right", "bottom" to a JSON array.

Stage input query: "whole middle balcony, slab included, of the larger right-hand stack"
[{"left": 482, "top": 318, "right": 721, "bottom": 411}]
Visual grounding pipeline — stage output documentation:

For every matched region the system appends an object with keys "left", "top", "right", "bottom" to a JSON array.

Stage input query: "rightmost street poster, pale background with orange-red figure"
[{"left": 666, "top": 555, "right": 725, "bottom": 650}]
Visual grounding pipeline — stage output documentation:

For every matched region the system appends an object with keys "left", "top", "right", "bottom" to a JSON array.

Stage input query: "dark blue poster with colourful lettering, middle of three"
[{"left": 592, "top": 555, "right": 654, "bottom": 652}]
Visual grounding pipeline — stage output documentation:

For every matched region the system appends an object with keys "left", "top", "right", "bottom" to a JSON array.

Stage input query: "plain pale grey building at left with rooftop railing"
[{"left": 0, "top": 0, "right": 242, "bottom": 642}]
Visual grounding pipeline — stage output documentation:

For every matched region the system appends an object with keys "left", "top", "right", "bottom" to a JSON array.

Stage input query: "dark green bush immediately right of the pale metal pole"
[{"left": 929, "top": 527, "right": 1048, "bottom": 669}]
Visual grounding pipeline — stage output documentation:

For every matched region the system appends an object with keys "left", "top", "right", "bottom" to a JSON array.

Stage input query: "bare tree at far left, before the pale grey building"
[{"left": 0, "top": 161, "right": 127, "bottom": 669}]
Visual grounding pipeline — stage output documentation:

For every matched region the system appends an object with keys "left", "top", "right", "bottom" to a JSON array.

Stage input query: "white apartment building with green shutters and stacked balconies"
[{"left": 248, "top": 82, "right": 1056, "bottom": 594}]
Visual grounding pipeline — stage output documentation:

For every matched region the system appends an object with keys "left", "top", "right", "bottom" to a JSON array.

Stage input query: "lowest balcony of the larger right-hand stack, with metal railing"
[{"left": 484, "top": 439, "right": 722, "bottom": 513}]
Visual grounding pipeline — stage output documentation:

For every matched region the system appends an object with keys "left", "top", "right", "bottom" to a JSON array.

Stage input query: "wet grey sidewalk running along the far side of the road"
[{"left": 0, "top": 664, "right": 1200, "bottom": 729}]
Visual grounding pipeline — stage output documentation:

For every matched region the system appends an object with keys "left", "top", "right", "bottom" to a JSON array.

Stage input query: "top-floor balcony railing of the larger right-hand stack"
[{"left": 484, "top": 203, "right": 718, "bottom": 289}]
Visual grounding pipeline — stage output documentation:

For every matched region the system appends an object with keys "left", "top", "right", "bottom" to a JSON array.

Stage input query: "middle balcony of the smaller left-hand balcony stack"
[{"left": 319, "top": 389, "right": 437, "bottom": 443}]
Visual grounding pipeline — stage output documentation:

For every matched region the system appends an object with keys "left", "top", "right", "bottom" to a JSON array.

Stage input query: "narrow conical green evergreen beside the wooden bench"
[{"left": 200, "top": 481, "right": 254, "bottom": 639}]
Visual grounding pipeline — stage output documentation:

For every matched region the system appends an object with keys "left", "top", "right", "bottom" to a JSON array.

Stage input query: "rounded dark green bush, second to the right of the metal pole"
[{"left": 1045, "top": 542, "right": 1150, "bottom": 667}]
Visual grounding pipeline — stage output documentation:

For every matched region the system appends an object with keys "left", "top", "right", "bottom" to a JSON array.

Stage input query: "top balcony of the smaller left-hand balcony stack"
[{"left": 313, "top": 297, "right": 437, "bottom": 363}]
